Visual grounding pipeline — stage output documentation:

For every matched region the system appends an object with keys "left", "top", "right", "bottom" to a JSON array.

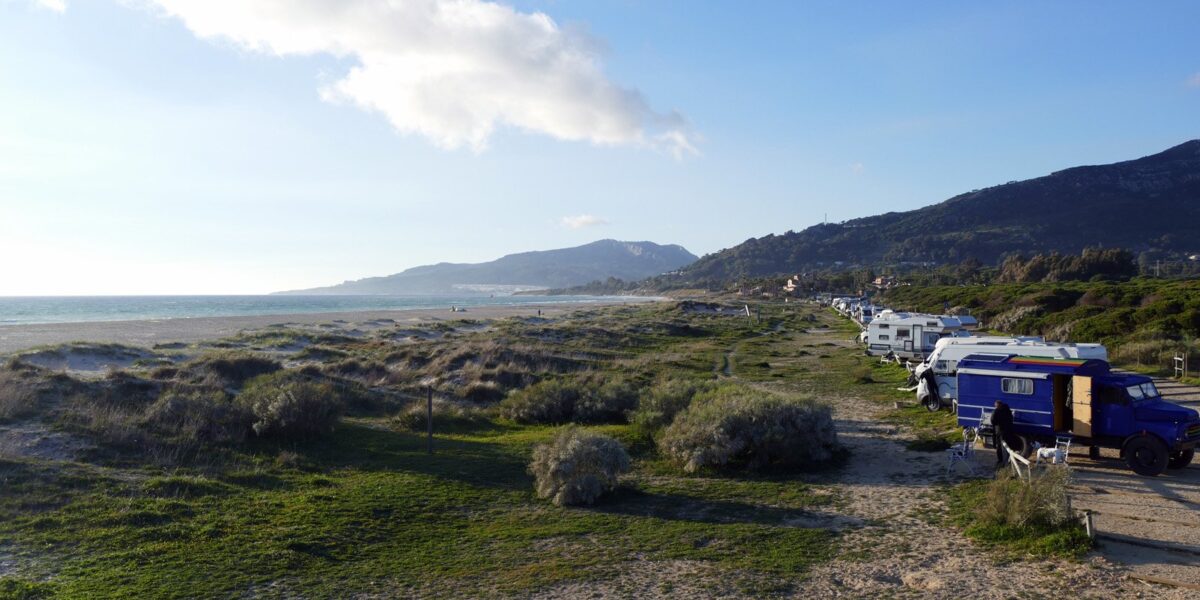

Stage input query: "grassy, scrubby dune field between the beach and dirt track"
[{"left": 0, "top": 304, "right": 1089, "bottom": 598}]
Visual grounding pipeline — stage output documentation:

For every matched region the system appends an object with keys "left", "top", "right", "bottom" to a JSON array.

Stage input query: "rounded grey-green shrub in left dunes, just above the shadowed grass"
[{"left": 238, "top": 372, "right": 342, "bottom": 439}]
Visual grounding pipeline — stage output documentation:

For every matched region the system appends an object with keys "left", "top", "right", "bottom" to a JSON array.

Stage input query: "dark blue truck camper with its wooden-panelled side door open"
[{"left": 958, "top": 354, "right": 1200, "bottom": 475}]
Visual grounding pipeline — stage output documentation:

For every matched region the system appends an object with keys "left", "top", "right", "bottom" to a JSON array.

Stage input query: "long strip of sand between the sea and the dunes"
[{"left": 0, "top": 299, "right": 654, "bottom": 355}]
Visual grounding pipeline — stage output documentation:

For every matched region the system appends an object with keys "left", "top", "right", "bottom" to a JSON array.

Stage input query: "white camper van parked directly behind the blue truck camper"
[{"left": 913, "top": 337, "right": 1109, "bottom": 410}]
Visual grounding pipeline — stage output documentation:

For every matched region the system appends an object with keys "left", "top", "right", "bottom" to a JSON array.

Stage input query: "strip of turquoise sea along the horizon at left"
[{"left": 0, "top": 295, "right": 638, "bottom": 326}]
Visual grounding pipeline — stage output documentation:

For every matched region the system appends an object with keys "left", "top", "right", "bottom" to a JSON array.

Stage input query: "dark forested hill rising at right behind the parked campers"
[{"left": 660, "top": 140, "right": 1200, "bottom": 284}]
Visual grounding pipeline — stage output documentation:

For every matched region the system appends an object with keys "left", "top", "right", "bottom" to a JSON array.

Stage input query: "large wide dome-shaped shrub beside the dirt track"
[{"left": 659, "top": 385, "right": 838, "bottom": 473}]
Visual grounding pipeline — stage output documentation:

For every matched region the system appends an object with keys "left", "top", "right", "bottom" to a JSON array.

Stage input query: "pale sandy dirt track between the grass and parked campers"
[{"left": 777, "top": 316, "right": 1171, "bottom": 599}]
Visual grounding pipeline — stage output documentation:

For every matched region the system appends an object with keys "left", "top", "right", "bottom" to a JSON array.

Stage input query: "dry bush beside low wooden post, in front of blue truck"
[{"left": 976, "top": 469, "right": 1072, "bottom": 529}]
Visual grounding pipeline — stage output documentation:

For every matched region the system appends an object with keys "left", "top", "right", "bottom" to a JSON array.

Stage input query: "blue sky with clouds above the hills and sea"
[{"left": 0, "top": 0, "right": 1200, "bottom": 295}]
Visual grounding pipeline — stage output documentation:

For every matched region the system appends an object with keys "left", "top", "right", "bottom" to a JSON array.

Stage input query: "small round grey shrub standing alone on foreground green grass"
[{"left": 529, "top": 427, "right": 629, "bottom": 506}]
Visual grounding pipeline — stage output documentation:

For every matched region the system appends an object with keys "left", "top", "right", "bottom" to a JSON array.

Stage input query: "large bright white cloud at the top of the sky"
[{"left": 133, "top": 0, "right": 697, "bottom": 157}]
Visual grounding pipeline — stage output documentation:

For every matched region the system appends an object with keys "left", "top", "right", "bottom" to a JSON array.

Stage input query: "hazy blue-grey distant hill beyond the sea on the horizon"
[{"left": 281, "top": 240, "right": 696, "bottom": 294}]
